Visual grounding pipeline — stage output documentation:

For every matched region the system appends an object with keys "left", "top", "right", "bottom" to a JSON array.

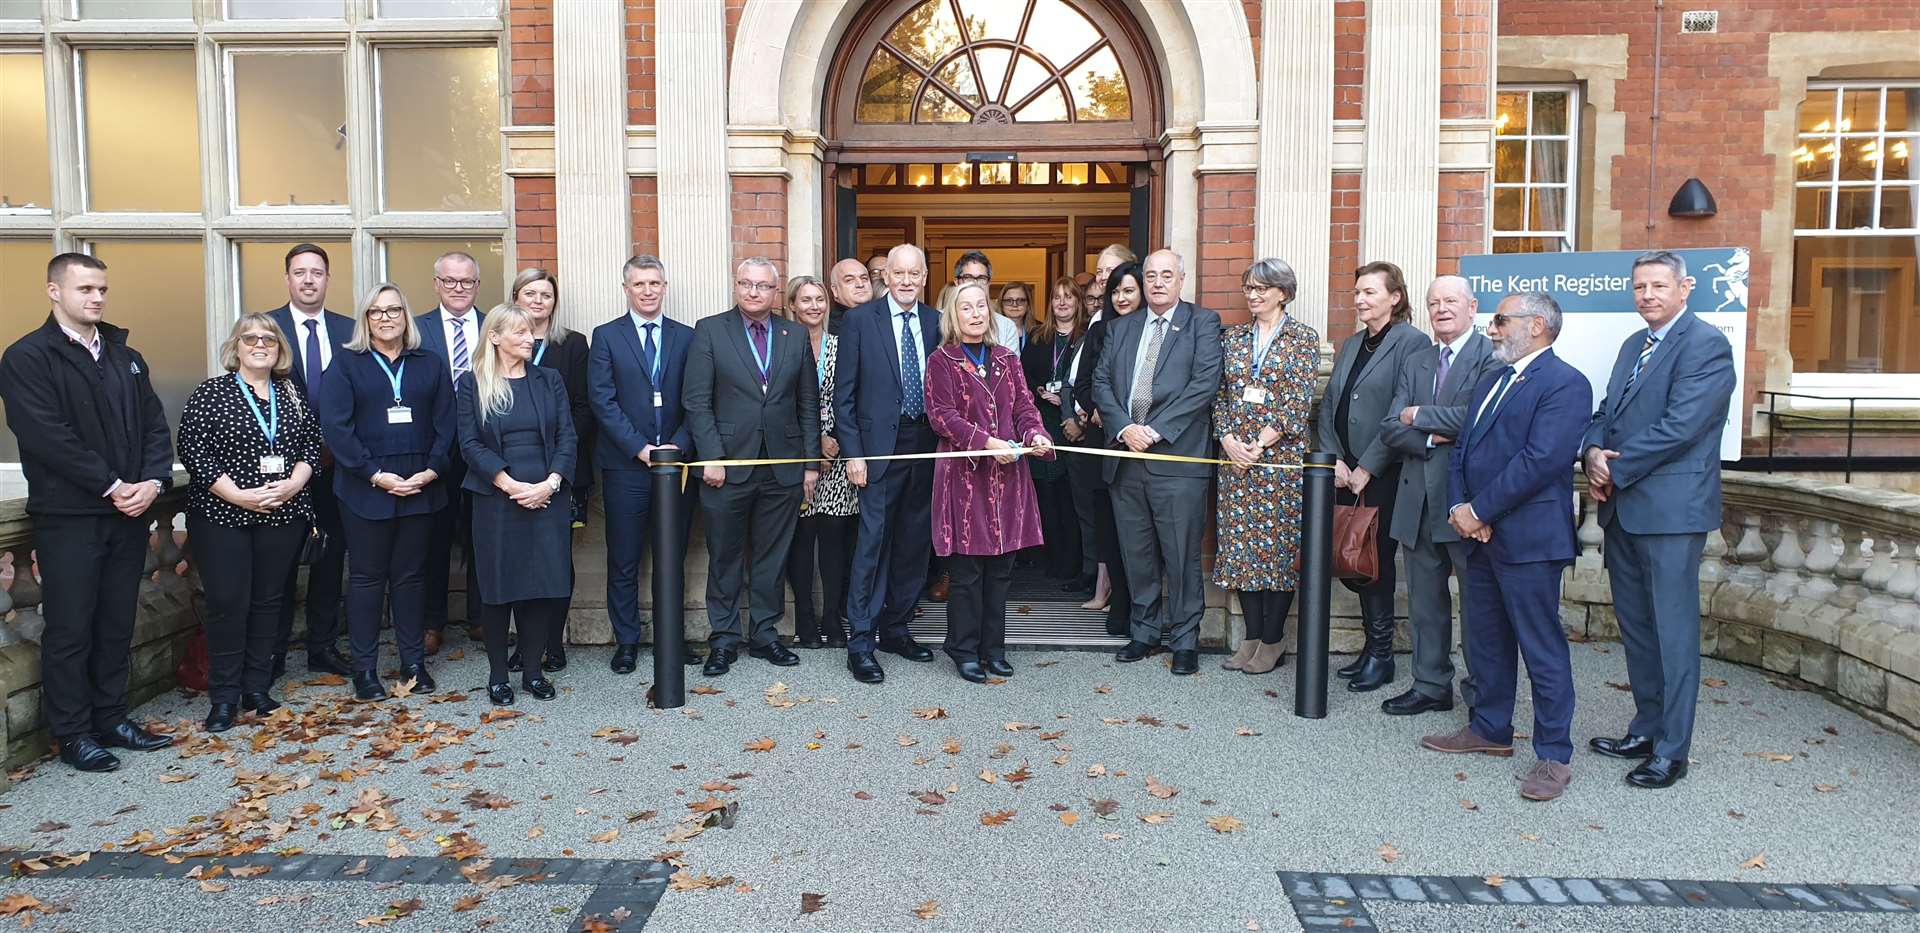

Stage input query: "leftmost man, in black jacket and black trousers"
[{"left": 0, "top": 253, "right": 173, "bottom": 772}]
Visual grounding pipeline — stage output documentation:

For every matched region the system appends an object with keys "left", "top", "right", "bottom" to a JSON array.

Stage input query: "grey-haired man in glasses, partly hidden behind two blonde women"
[{"left": 415, "top": 251, "right": 486, "bottom": 655}]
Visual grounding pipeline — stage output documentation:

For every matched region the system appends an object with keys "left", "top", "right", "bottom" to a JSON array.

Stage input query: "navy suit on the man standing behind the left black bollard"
[{"left": 588, "top": 313, "right": 699, "bottom": 645}]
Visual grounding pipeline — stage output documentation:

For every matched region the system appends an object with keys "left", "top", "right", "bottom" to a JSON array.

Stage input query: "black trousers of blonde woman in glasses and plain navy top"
[{"left": 340, "top": 509, "right": 444, "bottom": 672}]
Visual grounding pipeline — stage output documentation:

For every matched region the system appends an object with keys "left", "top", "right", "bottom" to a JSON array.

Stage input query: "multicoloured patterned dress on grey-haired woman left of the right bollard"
[{"left": 1213, "top": 315, "right": 1319, "bottom": 589}]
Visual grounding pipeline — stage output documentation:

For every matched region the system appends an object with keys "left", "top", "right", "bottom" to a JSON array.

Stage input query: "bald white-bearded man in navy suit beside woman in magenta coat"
[{"left": 833, "top": 244, "right": 941, "bottom": 683}]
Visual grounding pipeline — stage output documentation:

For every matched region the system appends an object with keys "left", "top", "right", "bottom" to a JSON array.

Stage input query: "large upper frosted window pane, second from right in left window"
[{"left": 232, "top": 52, "right": 348, "bottom": 207}]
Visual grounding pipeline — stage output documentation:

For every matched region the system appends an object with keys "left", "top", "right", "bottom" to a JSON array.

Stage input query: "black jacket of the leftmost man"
[{"left": 0, "top": 313, "right": 173, "bottom": 514}]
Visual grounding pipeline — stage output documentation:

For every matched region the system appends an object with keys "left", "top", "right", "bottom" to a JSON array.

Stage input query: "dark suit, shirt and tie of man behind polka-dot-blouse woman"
[{"left": 267, "top": 305, "right": 353, "bottom": 655}]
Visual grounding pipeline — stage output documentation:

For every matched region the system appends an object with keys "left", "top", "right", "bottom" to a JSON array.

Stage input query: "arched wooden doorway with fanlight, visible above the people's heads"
[{"left": 822, "top": 0, "right": 1165, "bottom": 292}]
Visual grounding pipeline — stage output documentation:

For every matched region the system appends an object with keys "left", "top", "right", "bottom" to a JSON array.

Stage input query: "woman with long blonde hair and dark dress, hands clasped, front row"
[{"left": 457, "top": 305, "right": 578, "bottom": 706}]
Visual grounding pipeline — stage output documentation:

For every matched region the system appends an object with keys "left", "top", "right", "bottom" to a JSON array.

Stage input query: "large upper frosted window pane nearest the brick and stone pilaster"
[{"left": 380, "top": 46, "right": 501, "bottom": 211}]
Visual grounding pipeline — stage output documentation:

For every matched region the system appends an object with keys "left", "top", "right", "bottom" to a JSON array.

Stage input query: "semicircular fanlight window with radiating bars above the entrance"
[{"left": 854, "top": 0, "right": 1133, "bottom": 123}]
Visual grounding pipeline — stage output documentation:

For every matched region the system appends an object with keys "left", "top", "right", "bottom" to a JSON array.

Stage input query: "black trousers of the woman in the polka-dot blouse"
[{"left": 186, "top": 513, "right": 307, "bottom": 703}]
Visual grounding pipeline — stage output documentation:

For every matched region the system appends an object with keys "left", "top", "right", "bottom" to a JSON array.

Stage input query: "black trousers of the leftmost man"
[{"left": 34, "top": 513, "right": 152, "bottom": 739}]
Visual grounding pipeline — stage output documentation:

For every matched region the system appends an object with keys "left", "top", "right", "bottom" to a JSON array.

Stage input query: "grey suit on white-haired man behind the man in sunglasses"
[{"left": 1380, "top": 334, "right": 1501, "bottom": 699}]
